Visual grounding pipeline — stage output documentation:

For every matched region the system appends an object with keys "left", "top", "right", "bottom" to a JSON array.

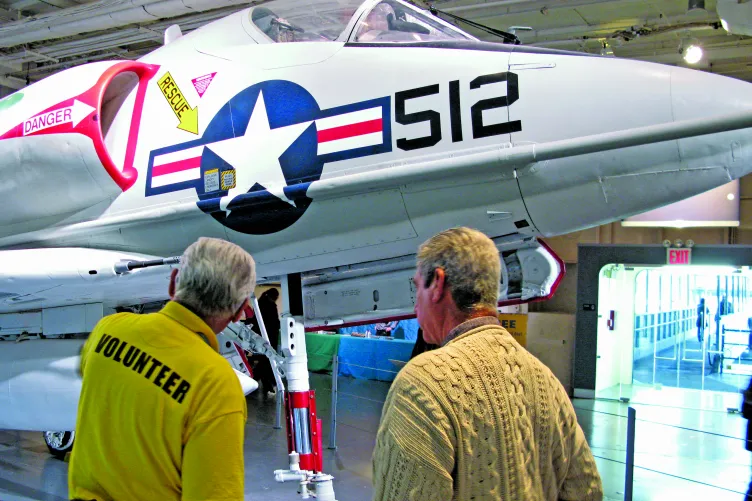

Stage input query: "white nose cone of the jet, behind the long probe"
[{"left": 671, "top": 67, "right": 752, "bottom": 181}]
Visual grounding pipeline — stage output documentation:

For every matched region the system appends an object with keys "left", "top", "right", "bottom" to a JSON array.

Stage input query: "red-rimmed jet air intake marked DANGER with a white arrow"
[{"left": 0, "top": 61, "right": 157, "bottom": 226}]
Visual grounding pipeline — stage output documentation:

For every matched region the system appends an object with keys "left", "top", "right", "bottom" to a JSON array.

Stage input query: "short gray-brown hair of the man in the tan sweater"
[{"left": 418, "top": 228, "right": 501, "bottom": 313}]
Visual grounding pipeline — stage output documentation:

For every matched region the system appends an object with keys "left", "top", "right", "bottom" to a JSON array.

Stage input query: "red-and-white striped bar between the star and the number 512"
[{"left": 316, "top": 106, "right": 384, "bottom": 155}]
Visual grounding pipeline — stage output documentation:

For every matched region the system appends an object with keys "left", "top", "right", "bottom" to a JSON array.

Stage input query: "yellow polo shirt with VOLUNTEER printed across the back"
[{"left": 68, "top": 302, "right": 246, "bottom": 501}]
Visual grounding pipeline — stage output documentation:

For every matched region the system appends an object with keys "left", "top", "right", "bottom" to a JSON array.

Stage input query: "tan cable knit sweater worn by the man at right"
[{"left": 373, "top": 317, "right": 603, "bottom": 501}]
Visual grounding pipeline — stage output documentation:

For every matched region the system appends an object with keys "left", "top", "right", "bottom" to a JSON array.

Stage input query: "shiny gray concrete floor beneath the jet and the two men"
[{"left": 0, "top": 375, "right": 751, "bottom": 501}]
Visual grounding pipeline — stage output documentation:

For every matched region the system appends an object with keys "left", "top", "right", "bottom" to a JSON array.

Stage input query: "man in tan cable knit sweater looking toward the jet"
[{"left": 373, "top": 228, "right": 603, "bottom": 501}]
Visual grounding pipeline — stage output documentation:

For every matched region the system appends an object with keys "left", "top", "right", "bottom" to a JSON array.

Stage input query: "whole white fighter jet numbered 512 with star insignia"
[{"left": 0, "top": 0, "right": 752, "bottom": 468}]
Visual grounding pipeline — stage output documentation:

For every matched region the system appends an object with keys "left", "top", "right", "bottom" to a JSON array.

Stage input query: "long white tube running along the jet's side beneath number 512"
[{"left": 0, "top": 109, "right": 752, "bottom": 247}]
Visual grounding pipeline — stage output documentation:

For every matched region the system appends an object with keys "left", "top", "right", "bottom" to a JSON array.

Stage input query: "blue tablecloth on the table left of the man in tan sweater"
[{"left": 339, "top": 336, "right": 415, "bottom": 381}]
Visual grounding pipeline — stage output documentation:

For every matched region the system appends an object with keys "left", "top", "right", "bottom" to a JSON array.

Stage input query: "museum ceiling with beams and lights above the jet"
[{"left": 0, "top": 0, "right": 752, "bottom": 89}]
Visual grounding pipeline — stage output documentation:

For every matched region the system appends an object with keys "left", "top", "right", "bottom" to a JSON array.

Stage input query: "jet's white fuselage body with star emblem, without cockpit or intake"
[{"left": 0, "top": 11, "right": 752, "bottom": 282}]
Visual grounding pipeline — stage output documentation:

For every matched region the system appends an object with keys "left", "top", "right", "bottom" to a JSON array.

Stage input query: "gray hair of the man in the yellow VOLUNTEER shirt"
[{"left": 175, "top": 237, "right": 256, "bottom": 318}]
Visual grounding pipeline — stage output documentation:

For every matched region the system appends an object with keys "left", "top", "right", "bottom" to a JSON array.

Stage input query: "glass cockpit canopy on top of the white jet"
[{"left": 250, "top": 0, "right": 475, "bottom": 43}]
